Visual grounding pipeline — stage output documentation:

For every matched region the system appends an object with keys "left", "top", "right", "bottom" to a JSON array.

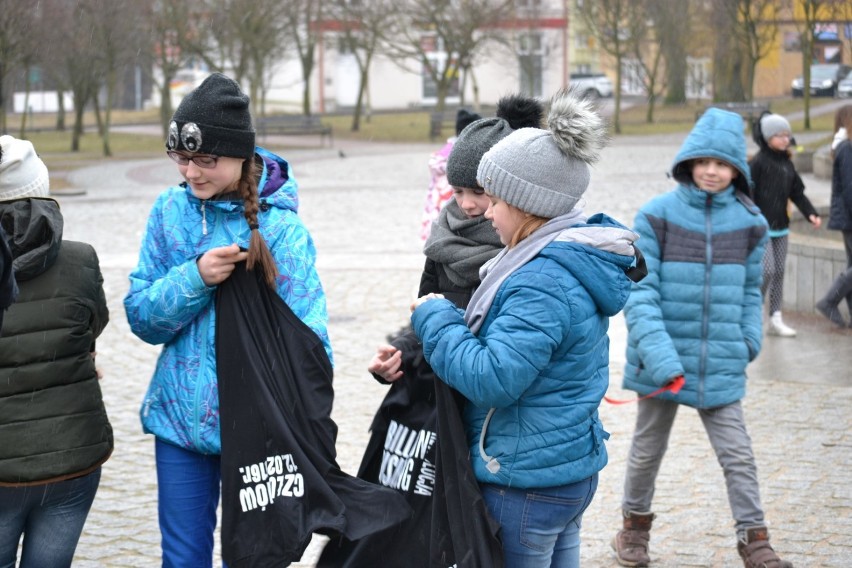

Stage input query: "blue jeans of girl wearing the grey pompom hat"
[{"left": 482, "top": 474, "right": 598, "bottom": 568}]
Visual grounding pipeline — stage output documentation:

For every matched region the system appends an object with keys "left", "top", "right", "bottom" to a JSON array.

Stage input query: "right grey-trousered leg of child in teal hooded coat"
[{"left": 698, "top": 401, "right": 764, "bottom": 534}]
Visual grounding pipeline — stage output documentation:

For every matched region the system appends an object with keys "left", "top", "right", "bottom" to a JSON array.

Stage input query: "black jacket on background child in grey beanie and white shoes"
[{"left": 749, "top": 149, "right": 819, "bottom": 233}]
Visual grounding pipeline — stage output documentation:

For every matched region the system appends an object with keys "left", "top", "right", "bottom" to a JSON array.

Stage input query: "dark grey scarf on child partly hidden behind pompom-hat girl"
[{"left": 423, "top": 199, "right": 503, "bottom": 288}]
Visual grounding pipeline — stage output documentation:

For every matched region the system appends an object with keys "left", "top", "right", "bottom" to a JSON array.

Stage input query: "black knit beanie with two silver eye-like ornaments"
[{"left": 166, "top": 73, "right": 255, "bottom": 159}]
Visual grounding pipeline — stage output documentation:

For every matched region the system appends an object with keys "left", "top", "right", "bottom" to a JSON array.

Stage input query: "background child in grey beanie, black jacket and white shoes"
[{"left": 749, "top": 111, "right": 822, "bottom": 337}]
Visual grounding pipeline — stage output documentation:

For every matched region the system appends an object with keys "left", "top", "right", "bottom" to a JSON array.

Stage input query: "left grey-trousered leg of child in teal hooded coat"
[{"left": 622, "top": 398, "right": 678, "bottom": 513}]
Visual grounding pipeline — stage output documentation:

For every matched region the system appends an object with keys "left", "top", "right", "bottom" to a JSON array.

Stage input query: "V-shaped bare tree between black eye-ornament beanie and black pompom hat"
[{"left": 328, "top": 0, "right": 395, "bottom": 132}]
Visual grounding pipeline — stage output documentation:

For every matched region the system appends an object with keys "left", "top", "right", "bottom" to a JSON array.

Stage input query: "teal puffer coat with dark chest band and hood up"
[{"left": 623, "top": 107, "right": 768, "bottom": 408}]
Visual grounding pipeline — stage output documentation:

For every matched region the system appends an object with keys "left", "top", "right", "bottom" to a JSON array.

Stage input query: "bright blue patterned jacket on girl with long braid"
[{"left": 124, "top": 148, "right": 331, "bottom": 454}]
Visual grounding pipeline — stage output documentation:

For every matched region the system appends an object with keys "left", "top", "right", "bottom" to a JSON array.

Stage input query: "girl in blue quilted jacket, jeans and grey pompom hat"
[{"left": 412, "top": 91, "right": 636, "bottom": 568}]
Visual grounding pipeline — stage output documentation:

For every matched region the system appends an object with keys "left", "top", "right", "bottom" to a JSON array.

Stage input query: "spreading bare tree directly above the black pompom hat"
[{"left": 387, "top": 0, "right": 513, "bottom": 111}]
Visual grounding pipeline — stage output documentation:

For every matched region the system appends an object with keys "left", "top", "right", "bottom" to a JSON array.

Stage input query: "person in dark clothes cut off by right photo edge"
[{"left": 816, "top": 105, "right": 852, "bottom": 327}]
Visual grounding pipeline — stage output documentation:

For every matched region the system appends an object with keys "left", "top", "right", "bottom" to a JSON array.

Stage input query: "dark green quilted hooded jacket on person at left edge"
[{"left": 0, "top": 199, "right": 113, "bottom": 486}]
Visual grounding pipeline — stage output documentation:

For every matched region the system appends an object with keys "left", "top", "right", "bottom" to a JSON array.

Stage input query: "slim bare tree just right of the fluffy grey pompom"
[{"left": 578, "top": 0, "right": 644, "bottom": 134}]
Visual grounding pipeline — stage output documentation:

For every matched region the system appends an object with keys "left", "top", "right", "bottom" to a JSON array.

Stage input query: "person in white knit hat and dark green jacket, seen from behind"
[{"left": 0, "top": 136, "right": 113, "bottom": 568}]
